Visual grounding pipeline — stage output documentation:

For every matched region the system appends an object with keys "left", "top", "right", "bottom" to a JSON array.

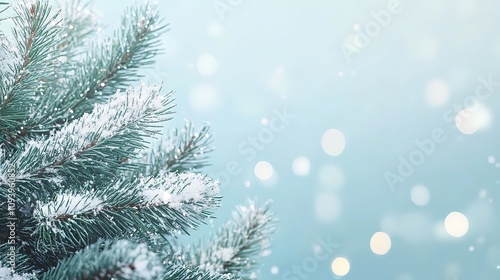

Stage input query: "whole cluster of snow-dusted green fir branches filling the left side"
[{"left": 0, "top": 0, "right": 274, "bottom": 280}]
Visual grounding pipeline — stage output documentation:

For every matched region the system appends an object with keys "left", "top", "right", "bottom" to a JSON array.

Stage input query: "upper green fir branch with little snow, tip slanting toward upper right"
[{"left": 39, "top": 5, "right": 166, "bottom": 127}]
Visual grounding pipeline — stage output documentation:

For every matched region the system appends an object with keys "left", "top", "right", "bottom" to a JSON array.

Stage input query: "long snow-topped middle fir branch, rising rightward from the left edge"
[{"left": 0, "top": 84, "right": 173, "bottom": 198}]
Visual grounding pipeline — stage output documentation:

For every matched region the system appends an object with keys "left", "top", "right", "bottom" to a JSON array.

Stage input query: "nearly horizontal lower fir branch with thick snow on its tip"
[{"left": 25, "top": 172, "right": 219, "bottom": 264}]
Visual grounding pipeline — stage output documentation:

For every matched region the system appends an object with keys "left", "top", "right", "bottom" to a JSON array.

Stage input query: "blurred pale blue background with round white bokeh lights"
[{"left": 7, "top": 0, "right": 500, "bottom": 280}]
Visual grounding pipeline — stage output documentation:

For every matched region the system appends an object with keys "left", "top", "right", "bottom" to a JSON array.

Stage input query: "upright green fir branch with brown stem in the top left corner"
[{"left": 0, "top": 1, "right": 59, "bottom": 147}]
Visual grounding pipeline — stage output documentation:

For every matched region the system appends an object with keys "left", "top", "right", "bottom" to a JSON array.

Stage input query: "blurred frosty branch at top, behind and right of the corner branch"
[{"left": 2, "top": 0, "right": 97, "bottom": 144}]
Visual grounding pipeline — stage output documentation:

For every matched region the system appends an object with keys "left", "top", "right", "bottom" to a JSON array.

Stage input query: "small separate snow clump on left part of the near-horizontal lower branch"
[{"left": 34, "top": 194, "right": 103, "bottom": 219}]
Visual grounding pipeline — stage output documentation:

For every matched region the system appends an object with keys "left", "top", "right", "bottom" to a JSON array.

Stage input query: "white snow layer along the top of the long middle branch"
[{"left": 4, "top": 83, "right": 167, "bottom": 181}]
